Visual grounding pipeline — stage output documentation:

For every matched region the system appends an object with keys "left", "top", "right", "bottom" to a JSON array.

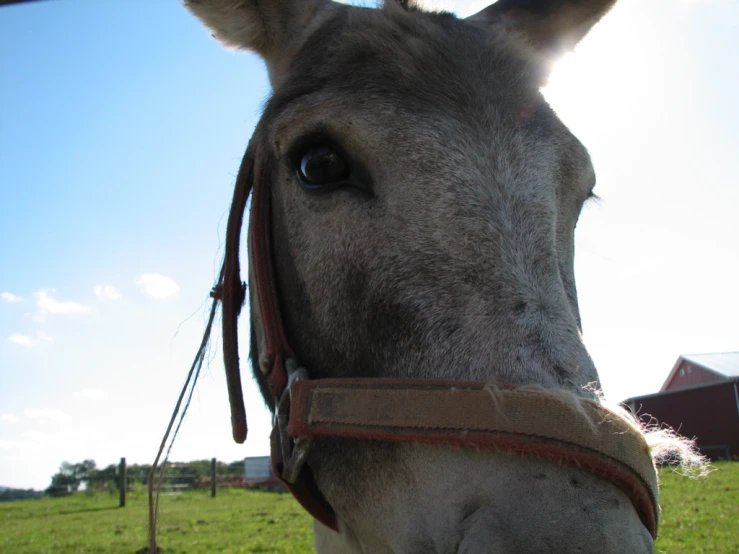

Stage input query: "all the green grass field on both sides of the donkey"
[{"left": 0, "top": 463, "right": 739, "bottom": 554}]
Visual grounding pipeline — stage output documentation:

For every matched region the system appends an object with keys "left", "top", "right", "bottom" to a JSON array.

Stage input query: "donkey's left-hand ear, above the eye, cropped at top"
[{"left": 185, "top": 0, "right": 333, "bottom": 86}]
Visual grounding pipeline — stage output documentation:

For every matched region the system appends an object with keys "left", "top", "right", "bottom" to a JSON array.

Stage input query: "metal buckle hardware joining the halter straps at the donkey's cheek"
[{"left": 275, "top": 358, "right": 313, "bottom": 483}]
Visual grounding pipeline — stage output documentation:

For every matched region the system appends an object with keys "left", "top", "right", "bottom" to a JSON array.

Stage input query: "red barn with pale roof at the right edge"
[{"left": 625, "top": 352, "right": 739, "bottom": 460}]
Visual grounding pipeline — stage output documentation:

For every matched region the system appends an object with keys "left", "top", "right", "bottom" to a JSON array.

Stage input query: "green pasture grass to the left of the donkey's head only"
[{"left": 0, "top": 489, "right": 313, "bottom": 554}]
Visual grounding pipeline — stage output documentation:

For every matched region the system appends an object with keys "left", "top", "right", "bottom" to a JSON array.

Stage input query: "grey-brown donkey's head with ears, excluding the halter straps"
[{"left": 186, "top": 0, "right": 653, "bottom": 554}]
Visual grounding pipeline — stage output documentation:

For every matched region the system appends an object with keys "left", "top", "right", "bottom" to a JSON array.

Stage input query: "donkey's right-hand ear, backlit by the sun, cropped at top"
[{"left": 467, "top": 0, "right": 616, "bottom": 58}]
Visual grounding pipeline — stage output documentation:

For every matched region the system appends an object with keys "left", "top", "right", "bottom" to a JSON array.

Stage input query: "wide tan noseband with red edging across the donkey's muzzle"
[{"left": 288, "top": 379, "right": 659, "bottom": 537}]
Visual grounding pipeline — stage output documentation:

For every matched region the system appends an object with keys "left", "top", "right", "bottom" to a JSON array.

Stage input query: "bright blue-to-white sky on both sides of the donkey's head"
[{"left": 0, "top": 0, "right": 739, "bottom": 488}]
